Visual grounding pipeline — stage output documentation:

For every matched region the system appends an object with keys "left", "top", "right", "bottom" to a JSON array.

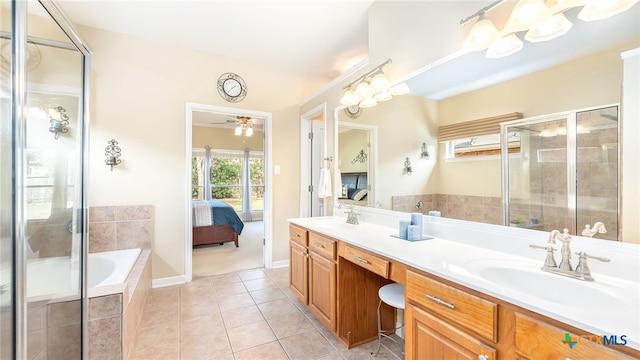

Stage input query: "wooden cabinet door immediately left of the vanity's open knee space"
[{"left": 309, "top": 251, "right": 336, "bottom": 331}]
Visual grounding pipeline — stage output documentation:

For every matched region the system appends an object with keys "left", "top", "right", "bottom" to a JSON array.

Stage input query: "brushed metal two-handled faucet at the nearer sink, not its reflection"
[{"left": 529, "top": 229, "right": 610, "bottom": 281}]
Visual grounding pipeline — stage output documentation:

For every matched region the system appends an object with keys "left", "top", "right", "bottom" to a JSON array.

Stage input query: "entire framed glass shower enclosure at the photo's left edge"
[{"left": 0, "top": 0, "right": 89, "bottom": 359}]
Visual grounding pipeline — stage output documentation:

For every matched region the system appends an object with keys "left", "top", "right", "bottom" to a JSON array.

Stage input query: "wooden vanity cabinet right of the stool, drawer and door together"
[{"left": 405, "top": 271, "right": 498, "bottom": 360}]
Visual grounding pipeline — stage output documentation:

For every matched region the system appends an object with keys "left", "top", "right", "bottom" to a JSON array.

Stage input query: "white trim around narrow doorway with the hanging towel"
[{"left": 300, "top": 102, "right": 327, "bottom": 217}]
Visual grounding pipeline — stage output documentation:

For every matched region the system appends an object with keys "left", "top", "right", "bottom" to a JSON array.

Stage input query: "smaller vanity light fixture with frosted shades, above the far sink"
[{"left": 340, "top": 59, "right": 409, "bottom": 108}]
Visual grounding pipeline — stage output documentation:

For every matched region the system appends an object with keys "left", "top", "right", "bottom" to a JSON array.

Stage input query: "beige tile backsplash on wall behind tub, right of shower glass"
[{"left": 89, "top": 205, "right": 153, "bottom": 253}]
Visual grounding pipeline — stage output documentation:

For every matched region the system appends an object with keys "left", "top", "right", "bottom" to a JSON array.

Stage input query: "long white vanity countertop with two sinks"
[{"left": 289, "top": 216, "right": 640, "bottom": 350}]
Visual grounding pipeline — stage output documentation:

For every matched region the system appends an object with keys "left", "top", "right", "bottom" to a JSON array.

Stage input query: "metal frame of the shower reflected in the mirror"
[{"left": 500, "top": 103, "right": 622, "bottom": 241}]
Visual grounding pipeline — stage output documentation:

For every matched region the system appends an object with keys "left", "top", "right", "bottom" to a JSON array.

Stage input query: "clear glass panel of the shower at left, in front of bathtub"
[{"left": 23, "top": 2, "right": 83, "bottom": 359}]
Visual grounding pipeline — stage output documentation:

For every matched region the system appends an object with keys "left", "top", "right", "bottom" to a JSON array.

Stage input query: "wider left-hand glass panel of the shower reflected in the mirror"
[{"left": 505, "top": 116, "right": 575, "bottom": 231}]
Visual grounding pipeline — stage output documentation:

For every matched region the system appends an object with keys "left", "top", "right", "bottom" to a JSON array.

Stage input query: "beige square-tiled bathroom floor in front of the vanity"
[{"left": 130, "top": 268, "right": 401, "bottom": 360}]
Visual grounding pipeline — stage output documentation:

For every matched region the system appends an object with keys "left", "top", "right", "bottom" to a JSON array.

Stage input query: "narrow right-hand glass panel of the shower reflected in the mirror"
[{"left": 576, "top": 106, "right": 619, "bottom": 240}]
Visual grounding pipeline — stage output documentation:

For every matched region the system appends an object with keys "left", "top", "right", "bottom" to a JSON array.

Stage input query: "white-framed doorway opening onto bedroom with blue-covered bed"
[{"left": 185, "top": 103, "right": 271, "bottom": 281}]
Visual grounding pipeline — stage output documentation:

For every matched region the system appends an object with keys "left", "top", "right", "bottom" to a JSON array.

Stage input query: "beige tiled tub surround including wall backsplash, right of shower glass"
[{"left": 89, "top": 205, "right": 153, "bottom": 359}]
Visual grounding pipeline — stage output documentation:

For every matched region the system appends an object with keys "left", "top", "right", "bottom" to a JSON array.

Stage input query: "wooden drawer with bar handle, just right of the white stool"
[{"left": 405, "top": 271, "right": 498, "bottom": 342}]
